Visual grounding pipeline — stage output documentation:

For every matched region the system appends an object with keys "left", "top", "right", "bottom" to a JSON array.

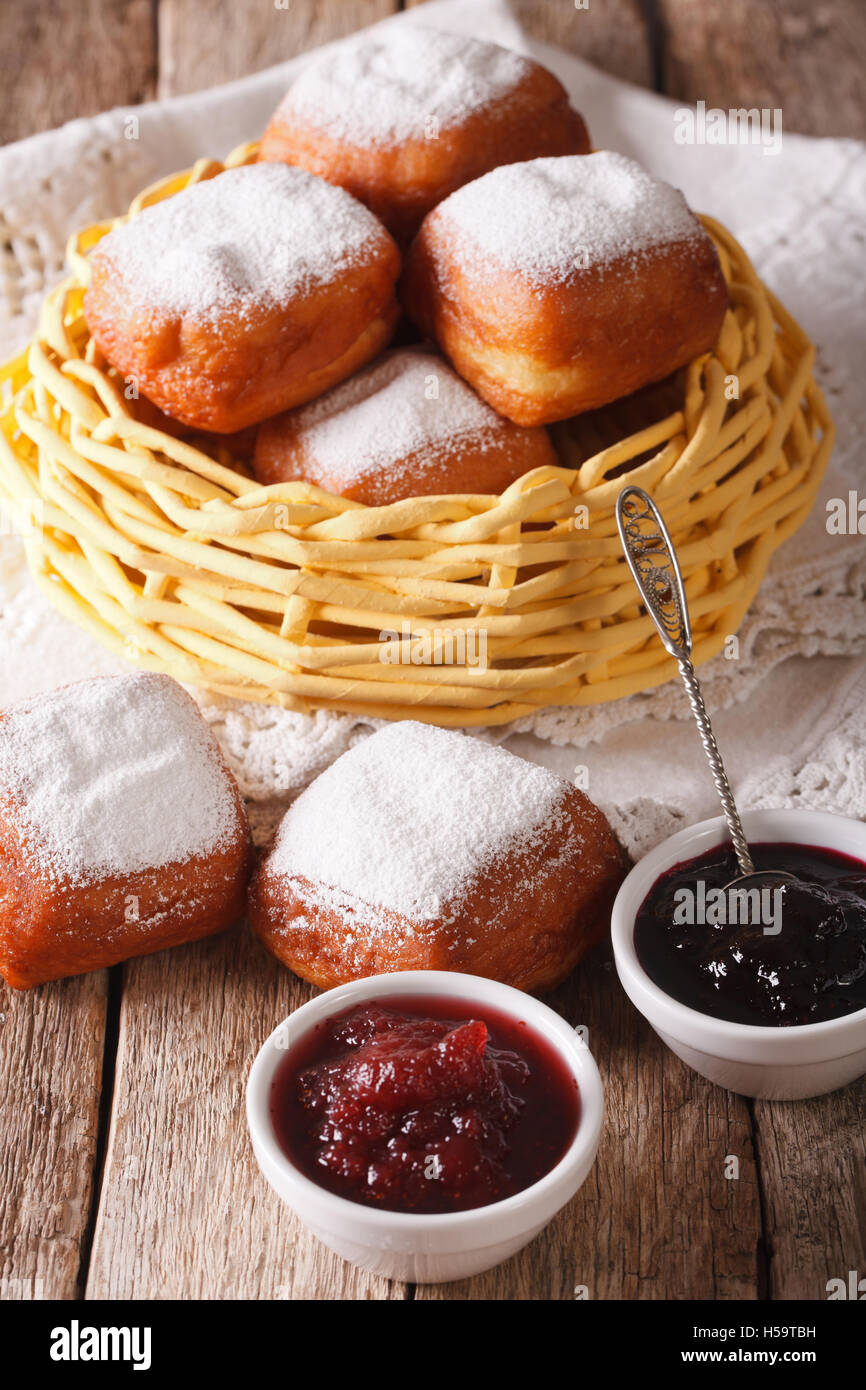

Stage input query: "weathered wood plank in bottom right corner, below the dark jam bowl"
[{"left": 755, "top": 1079, "right": 866, "bottom": 1298}]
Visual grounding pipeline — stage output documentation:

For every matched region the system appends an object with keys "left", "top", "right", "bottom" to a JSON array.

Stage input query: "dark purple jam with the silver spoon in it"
[{"left": 634, "top": 844, "right": 866, "bottom": 1027}]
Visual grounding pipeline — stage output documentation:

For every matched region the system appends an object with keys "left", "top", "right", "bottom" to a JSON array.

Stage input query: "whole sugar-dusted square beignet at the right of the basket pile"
[{"left": 402, "top": 152, "right": 727, "bottom": 425}]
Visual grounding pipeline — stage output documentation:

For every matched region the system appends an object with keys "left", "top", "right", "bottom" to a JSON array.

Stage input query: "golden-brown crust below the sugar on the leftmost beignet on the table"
[{"left": 0, "top": 788, "right": 252, "bottom": 990}]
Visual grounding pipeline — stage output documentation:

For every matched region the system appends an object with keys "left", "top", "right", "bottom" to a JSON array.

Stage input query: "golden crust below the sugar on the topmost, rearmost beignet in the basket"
[{"left": 259, "top": 64, "right": 591, "bottom": 245}]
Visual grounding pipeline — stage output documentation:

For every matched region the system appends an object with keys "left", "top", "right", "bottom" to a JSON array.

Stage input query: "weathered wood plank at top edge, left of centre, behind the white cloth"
[{"left": 158, "top": 0, "right": 399, "bottom": 97}]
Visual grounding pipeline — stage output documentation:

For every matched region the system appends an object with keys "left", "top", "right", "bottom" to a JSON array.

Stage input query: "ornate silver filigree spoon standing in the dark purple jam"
[{"left": 616, "top": 484, "right": 798, "bottom": 891}]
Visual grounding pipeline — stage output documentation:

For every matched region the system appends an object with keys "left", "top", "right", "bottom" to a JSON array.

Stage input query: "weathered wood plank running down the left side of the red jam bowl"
[{"left": 86, "top": 927, "right": 406, "bottom": 1300}]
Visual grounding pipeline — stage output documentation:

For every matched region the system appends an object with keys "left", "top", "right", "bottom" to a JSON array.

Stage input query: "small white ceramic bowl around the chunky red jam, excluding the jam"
[{"left": 246, "top": 970, "right": 603, "bottom": 1283}]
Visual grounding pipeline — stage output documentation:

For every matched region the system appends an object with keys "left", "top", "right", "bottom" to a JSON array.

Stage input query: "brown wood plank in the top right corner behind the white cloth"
[{"left": 657, "top": 0, "right": 866, "bottom": 139}]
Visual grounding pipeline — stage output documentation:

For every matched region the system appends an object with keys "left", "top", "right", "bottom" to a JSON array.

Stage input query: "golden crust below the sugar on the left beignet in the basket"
[{"left": 83, "top": 239, "right": 400, "bottom": 434}]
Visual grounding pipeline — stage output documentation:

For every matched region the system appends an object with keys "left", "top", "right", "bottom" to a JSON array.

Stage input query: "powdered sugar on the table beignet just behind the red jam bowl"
[{"left": 267, "top": 720, "right": 569, "bottom": 924}]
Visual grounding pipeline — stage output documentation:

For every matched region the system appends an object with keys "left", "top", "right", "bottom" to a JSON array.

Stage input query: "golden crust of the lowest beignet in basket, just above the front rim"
[{"left": 253, "top": 411, "right": 559, "bottom": 507}]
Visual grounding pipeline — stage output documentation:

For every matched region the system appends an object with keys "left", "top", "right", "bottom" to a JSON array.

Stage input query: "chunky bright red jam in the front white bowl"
[{"left": 271, "top": 995, "right": 580, "bottom": 1213}]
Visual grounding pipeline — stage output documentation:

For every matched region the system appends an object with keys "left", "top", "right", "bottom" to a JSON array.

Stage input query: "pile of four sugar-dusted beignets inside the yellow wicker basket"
[{"left": 83, "top": 24, "right": 727, "bottom": 506}]
